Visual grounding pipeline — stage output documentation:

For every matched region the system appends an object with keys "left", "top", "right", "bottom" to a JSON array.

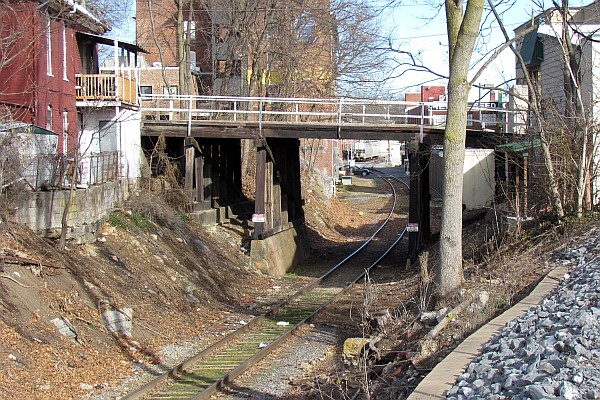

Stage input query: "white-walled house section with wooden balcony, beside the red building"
[{"left": 77, "top": 34, "right": 144, "bottom": 186}]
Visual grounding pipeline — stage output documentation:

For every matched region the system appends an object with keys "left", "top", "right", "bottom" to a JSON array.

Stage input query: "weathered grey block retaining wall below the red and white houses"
[{"left": 12, "top": 179, "right": 129, "bottom": 243}]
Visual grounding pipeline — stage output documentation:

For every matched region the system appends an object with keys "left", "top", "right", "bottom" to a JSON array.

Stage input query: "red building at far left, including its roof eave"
[{"left": 0, "top": 0, "right": 108, "bottom": 154}]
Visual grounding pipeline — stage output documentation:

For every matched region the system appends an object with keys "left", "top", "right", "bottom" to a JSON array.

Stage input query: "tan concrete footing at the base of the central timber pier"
[{"left": 250, "top": 225, "right": 310, "bottom": 277}]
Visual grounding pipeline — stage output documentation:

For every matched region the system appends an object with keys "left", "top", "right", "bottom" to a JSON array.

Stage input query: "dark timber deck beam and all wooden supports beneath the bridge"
[{"left": 143, "top": 121, "right": 498, "bottom": 276}]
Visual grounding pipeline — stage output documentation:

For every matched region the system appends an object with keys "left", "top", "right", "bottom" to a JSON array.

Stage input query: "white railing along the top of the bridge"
[{"left": 141, "top": 94, "right": 524, "bottom": 131}]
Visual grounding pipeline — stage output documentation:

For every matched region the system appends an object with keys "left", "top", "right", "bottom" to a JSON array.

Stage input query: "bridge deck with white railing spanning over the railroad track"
[{"left": 142, "top": 95, "right": 511, "bottom": 144}]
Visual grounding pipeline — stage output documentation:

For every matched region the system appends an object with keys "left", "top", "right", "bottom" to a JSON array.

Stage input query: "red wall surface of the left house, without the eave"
[{"left": 0, "top": 2, "right": 100, "bottom": 155}]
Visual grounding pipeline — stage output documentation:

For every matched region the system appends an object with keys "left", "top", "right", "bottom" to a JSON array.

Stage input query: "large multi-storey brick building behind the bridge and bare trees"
[{"left": 136, "top": 0, "right": 340, "bottom": 196}]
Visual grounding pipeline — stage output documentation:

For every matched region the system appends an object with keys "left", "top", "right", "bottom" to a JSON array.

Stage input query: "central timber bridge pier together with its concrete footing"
[{"left": 250, "top": 139, "right": 310, "bottom": 276}]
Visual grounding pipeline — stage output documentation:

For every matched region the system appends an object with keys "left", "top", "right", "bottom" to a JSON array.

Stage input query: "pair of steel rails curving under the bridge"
[{"left": 123, "top": 171, "right": 408, "bottom": 400}]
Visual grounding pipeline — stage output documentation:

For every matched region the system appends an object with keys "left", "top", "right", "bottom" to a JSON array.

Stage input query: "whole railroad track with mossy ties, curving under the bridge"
[{"left": 123, "top": 171, "right": 406, "bottom": 400}]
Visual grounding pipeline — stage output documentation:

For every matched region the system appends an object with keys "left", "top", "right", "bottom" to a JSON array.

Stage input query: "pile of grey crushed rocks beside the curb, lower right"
[{"left": 447, "top": 231, "right": 600, "bottom": 399}]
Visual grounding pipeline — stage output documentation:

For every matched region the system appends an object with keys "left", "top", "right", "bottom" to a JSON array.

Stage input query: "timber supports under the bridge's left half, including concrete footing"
[{"left": 142, "top": 136, "right": 310, "bottom": 276}]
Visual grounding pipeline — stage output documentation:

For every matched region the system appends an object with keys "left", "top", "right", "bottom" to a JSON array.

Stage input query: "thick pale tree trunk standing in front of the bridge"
[{"left": 435, "top": 0, "right": 484, "bottom": 297}]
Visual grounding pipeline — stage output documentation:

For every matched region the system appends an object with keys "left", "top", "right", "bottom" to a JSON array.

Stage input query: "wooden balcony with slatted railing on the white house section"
[{"left": 75, "top": 71, "right": 138, "bottom": 106}]
